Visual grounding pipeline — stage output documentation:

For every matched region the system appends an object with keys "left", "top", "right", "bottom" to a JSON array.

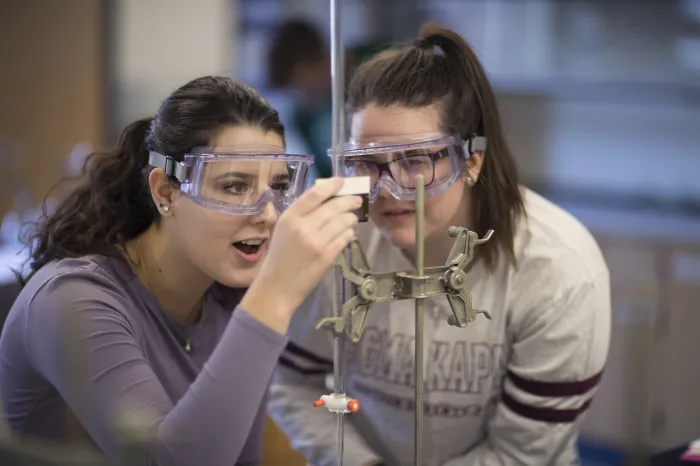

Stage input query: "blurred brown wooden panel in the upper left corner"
[{"left": 0, "top": 0, "right": 105, "bottom": 218}]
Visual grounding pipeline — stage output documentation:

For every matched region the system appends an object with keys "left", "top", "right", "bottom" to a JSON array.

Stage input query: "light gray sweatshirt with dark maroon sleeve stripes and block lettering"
[{"left": 269, "top": 189, "right": 611, "bottom": 466}]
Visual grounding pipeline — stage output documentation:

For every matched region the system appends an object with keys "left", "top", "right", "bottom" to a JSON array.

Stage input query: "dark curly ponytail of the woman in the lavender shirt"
[{"left": 17, "top": 118, "right": 157, "bottom": 286}]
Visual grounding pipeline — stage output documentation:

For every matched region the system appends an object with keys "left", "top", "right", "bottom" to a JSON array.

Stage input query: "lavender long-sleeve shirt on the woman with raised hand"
[{"left": 0, "top": 256, "right": 287, "bottom": 466}]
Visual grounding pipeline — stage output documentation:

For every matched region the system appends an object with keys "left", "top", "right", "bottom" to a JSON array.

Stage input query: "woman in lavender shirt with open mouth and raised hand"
[{"left": 0, "top": 77, "right": 362, "bottom": 466}]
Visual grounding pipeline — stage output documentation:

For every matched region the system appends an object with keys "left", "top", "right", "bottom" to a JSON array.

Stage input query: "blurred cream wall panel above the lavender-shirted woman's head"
[{"left": 110, "top": 0, "right": 236, "bottom": 135}]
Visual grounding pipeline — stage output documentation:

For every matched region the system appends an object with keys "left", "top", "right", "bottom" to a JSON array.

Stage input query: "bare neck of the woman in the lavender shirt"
[{"left": 127, "top": 224, "right": 213, "bottom": 324}]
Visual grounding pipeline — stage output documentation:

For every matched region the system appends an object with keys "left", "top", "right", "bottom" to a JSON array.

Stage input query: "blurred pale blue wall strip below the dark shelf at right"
[{"left": 499, "top": 95, "right": 700, "bottom": 199}]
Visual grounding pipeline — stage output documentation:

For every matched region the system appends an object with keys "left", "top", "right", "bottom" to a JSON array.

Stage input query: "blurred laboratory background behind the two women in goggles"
[{"left": 0, "top": 0, "right": 700, "bottom": 466}]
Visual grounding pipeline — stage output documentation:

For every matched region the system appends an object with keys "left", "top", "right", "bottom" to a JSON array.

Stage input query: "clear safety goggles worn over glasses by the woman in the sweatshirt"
[{"left": 328, "top": 133, "right": 486, "bottom": 202}]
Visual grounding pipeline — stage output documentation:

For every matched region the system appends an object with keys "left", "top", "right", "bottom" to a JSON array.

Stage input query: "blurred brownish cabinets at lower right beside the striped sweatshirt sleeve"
[{"left": 582, "top": 237, "right": 700, "bottom": 452}]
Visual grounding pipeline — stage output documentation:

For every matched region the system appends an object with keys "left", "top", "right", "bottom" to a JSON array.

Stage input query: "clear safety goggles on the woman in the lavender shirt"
[{"left": 148, "top": 146, "right": 314, "bottom": 215}]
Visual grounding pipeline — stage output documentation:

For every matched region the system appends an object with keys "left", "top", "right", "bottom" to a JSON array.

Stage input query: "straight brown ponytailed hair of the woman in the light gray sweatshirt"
[{"left": 348, "top": 23, "right": 525, "bottom": 267}]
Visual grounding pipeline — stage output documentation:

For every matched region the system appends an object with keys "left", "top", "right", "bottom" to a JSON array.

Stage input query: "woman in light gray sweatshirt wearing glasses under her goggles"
[{"left": 270, "top": 24, "right": 610, "bottom": 466}]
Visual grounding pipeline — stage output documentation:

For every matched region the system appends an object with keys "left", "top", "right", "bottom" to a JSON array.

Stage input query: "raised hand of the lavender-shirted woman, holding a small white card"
[{"left": 241, "top": 178, "right": 362, "bottom": 333}]
